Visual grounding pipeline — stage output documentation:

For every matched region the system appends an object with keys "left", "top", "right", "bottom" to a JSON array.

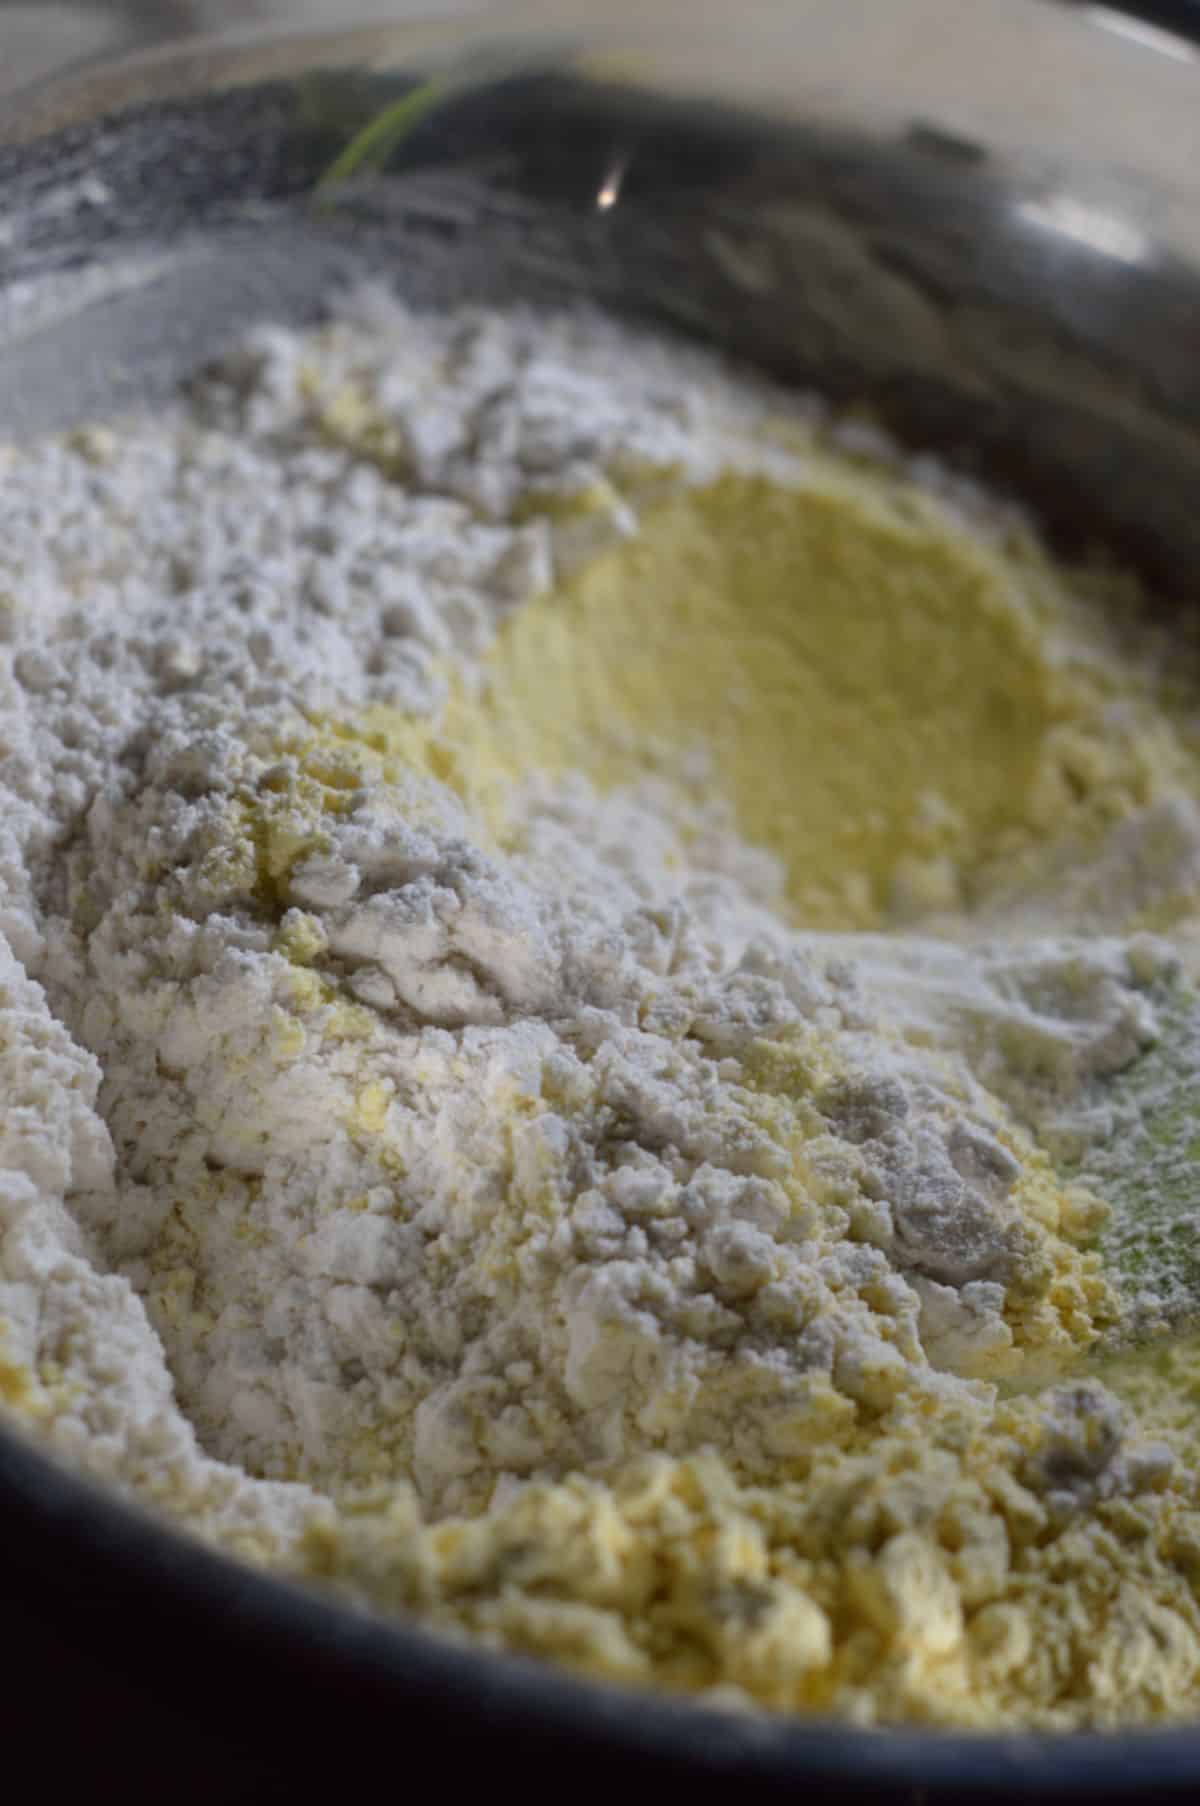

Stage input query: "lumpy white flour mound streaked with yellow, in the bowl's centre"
[{"left": 37, "top": 726, "right": 1088, "bottom": 1510}]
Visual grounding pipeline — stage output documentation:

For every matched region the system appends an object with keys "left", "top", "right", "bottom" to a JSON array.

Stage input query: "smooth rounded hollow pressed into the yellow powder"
[{"left": 488, "top": 477, "right": 1070, "bottom": 926}]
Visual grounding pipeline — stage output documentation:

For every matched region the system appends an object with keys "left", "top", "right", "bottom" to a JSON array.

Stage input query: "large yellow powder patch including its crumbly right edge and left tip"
[{"left": 327, "top": 462, "right": 1187, "bottom": 928}]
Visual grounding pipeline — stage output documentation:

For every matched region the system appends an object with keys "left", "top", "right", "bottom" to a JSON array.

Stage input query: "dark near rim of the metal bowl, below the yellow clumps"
[{"left": 9, "top": 1423, "right": 1200, "bottom": 1802}]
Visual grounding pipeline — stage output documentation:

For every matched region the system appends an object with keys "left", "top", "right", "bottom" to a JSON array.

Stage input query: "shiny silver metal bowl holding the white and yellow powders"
[{"left": 0, "top": 0, "right": 1200, "bottom": 1802}]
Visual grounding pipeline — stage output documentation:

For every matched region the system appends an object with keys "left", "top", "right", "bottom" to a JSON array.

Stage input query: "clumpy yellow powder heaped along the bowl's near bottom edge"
[{"left": 307, "top": 1392, "right": 1200, "bottom": 1730}]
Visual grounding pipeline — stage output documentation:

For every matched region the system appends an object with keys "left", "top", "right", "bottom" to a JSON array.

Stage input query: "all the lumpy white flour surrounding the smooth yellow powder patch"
[{"left": 0, "top": 296, "right": 1200, "bottom": 1712}]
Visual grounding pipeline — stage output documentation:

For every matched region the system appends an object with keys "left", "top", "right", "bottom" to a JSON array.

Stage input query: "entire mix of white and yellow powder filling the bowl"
[{"left": 0, "top": 291, "right": 1200, "bottom": 1728}]
